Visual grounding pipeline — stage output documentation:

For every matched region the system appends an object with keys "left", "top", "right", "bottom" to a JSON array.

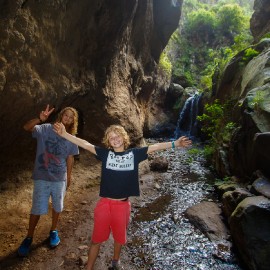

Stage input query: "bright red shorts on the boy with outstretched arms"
[{"left": 92, "top": 198, "right": 131, "bottom": 245}]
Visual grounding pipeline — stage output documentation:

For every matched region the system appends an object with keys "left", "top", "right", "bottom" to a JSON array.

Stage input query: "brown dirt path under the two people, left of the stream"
[{"left": 0, "top": 152, "right": 157, "bottom": 270}]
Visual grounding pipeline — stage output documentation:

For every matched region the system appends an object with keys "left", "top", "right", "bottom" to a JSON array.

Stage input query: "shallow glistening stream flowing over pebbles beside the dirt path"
[{"left": 128, "top": 142, "right": 242, "bottom": 270}]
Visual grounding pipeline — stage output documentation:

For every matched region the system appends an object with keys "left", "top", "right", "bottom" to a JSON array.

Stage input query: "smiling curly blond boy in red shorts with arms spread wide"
[{"left": 54, "top": 123, "right": 191, "bottom": 270}]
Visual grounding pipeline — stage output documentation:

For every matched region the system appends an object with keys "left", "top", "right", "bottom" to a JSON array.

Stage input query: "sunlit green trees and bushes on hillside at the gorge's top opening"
[{"left": 166, "top": 0, "right": 253, "bottom": 91}]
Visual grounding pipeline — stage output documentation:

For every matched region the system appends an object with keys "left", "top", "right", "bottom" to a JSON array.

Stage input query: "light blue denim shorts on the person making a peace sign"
[{"left": 31, "top": 180, "right": 66, "bottom": 215}]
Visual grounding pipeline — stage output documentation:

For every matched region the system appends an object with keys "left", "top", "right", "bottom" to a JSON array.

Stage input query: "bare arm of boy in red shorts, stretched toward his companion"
[{"left": 53, "top": 123, "right": 96, "bottom": 155}]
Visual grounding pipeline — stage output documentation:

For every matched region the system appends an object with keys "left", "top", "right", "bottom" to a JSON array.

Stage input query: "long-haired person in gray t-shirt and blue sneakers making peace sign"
[{"left": 18, "top": 105, "right": 79, "bottom": 257}]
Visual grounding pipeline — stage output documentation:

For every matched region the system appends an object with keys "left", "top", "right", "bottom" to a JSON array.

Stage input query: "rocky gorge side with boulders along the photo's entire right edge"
[{"left": 194, "top": 0, "right": 270, "bottom": 270}]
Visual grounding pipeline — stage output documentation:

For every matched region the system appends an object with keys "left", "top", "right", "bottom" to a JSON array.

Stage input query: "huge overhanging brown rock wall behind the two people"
[{"left": 0, "top": 0, "right": 182, "bottom": 182}]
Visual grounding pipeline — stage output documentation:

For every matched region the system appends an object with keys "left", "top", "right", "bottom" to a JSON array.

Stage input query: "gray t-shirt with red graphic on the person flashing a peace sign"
[{"left": 32, "top": 124, "right": 79, "bottom": 181}]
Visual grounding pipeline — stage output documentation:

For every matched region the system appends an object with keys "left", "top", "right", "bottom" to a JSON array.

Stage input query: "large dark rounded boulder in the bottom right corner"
[{"left": 229, "top": 196, "right": 270, "bottom": 270}]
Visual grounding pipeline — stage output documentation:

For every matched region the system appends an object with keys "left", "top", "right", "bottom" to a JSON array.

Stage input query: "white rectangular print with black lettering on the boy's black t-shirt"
[{"left": 106, "top": 151, "right": 134, "bottom": 171}]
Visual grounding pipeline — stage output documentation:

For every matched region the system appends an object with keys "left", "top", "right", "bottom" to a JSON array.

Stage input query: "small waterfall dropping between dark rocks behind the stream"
[{"left": 174, "top": 94, "right": 201, "bottom": 138}]
